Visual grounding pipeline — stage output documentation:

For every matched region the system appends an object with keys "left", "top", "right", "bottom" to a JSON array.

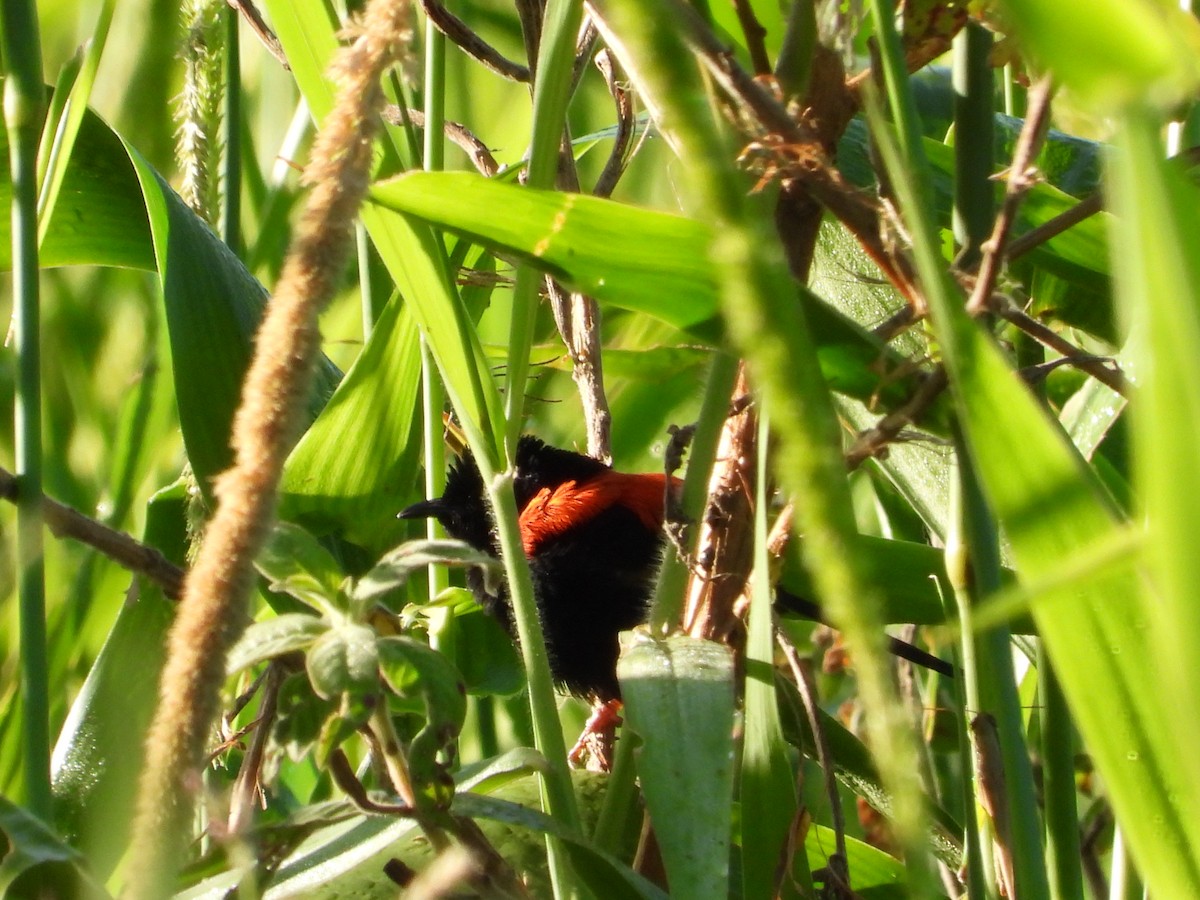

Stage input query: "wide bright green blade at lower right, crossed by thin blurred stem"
[{"left": 942, "top": 307, "right": 1200, "bottom": 896}]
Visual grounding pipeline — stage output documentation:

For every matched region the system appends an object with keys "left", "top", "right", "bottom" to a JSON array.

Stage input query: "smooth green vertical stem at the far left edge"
[{"left": 0, "top": 0, "right": 52, "bottom": 822}]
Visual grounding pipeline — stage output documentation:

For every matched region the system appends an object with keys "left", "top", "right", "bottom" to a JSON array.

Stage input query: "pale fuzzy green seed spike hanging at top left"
[{"left": 175, "top": 0, "right": 225, "bottom": 224}]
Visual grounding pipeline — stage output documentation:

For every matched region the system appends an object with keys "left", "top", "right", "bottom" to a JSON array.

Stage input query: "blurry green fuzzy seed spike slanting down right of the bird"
[{"left": 594, "top": 0, "right": 931, "bottom": 895}]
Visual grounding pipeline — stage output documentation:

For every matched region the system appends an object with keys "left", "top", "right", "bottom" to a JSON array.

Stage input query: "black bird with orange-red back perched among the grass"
[{"left": 398, "top": 434, "right": 953, "bottom": 703}]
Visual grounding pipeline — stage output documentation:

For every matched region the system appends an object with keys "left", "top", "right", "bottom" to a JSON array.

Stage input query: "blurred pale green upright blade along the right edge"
[{"left": 1111, "top": 114, "right": 1200, "bottom": 895}]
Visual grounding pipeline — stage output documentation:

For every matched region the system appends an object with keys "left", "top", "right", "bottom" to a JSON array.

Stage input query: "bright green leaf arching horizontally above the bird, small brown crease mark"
[{"left": 371, "top": 172, "right": 944, "bottom": 420}]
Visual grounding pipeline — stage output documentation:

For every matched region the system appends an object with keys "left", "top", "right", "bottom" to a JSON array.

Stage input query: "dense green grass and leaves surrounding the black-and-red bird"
[{"left": 0, "top": 0, "right": 1200, "bottom": 900}]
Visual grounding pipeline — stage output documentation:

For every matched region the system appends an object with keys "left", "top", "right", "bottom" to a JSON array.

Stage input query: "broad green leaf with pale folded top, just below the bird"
[{"left": 617, "top": 631, "right": 733, "bottom": 898}]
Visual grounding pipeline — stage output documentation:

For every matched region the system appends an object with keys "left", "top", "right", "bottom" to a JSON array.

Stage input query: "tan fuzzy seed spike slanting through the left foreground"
[{"left": 128, "top": 0, "right": 409, "bottom": 900}]
